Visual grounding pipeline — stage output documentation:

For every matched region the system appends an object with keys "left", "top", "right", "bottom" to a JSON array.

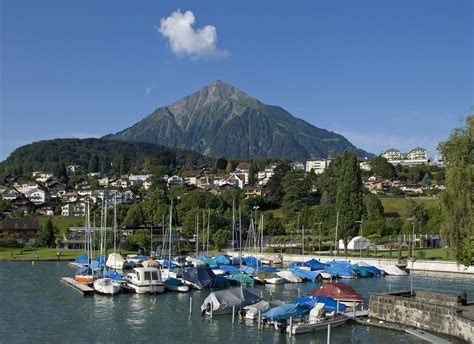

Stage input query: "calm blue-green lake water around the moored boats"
[{"left": 0, "top": 262, "right": 474, "bottom": 344}]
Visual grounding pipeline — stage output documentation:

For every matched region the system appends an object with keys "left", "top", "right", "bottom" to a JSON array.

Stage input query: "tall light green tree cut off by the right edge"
[{"left": 438, "top": 116, "right": 474, "bottom": 266}]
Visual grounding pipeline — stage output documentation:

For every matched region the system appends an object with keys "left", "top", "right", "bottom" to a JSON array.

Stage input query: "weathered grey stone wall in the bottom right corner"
[{"left": 369, "top": 292, "right": 474, "bottom": 343}]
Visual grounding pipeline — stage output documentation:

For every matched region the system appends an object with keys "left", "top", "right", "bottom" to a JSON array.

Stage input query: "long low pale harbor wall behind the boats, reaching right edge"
[{"left": 228, "top": 251, "right": 474, "bottom": 276}]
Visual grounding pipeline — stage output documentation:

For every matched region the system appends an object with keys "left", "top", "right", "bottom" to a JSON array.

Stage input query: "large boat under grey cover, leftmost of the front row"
[{"left": 201, "top": 288, "right": 261, "bottom": 315}]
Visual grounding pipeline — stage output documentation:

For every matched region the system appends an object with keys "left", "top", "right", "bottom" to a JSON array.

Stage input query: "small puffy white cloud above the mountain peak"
[{"left": 157, "top": 10, "right": 230, "bottom": 58}]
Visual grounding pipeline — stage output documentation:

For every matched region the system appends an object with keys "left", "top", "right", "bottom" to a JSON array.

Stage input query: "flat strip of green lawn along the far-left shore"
[{"left": 0, "top": 247, "right": 137, "bottom": 261}]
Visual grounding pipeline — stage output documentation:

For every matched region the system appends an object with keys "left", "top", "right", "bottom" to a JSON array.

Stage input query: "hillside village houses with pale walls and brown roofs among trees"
[{"left": 0, "top": 148, "right": 444, "bottom": 217}]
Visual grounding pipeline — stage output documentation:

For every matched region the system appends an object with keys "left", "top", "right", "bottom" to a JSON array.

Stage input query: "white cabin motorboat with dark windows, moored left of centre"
[{"left": 124, "top": 268, "right": 165, "bottom": 294}]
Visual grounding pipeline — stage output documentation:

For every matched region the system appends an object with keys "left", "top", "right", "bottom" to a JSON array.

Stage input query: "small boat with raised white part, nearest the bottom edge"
[{"left": 286, "top": 303, "right": 348, "bottom": 335}]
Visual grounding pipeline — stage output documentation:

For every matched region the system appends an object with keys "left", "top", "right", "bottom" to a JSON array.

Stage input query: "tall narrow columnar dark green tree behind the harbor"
[{"left": 336, "top": 151, "right": 363, "bottom": 254}]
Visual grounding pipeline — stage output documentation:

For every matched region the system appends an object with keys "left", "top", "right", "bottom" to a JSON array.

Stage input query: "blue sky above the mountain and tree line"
[{"left": 0, "top": 0, "right": 474, "bottom": 160}]
